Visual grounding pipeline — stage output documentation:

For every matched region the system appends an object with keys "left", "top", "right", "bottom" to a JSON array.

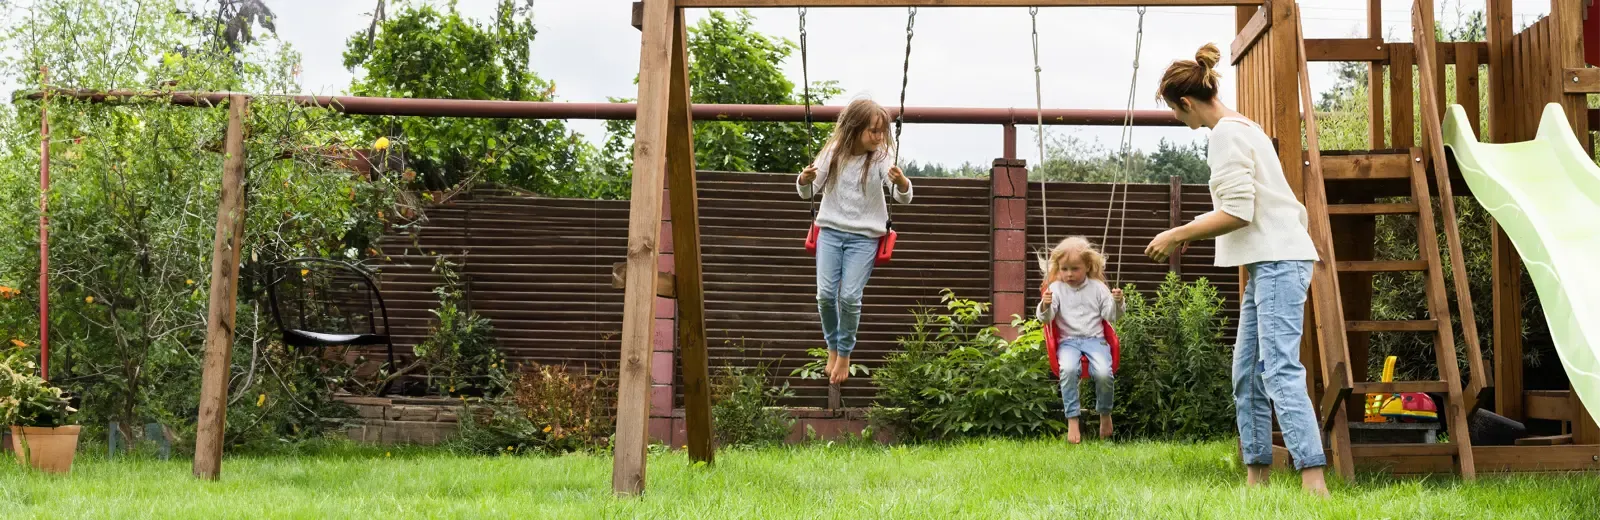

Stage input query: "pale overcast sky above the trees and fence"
[{"left": 18, "top": 0, "right": 1550, "bottom": 165}]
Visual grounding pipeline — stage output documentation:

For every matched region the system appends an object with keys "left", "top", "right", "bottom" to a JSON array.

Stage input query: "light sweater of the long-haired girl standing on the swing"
[{"left": 795, "top": 142, "right": 910, "bottom": 237}]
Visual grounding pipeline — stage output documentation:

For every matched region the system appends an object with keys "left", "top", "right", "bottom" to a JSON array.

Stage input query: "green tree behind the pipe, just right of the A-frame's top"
[{"left": 603, "top": 11, "right": 843, "bottom": 173}]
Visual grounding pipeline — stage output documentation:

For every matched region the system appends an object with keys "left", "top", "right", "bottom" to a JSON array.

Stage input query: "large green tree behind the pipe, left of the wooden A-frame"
[{"left": 344, "top": 0, "right": 626, "bottom": 197}]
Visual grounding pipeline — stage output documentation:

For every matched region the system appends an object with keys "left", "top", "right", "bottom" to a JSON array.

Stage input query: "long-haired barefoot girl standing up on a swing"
[{"left": 795, "top": 99, "right": 910, "bottom": 384}]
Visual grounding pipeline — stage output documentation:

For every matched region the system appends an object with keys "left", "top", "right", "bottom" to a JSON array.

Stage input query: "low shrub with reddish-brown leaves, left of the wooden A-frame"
[{"left": 450, "top": 363, "right": 616, "bottom": 454}]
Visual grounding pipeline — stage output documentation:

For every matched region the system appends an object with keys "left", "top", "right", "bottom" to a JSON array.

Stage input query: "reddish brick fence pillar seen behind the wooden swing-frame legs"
[{"left": 650, "top": 190, "right": 685, "bottom": 446}]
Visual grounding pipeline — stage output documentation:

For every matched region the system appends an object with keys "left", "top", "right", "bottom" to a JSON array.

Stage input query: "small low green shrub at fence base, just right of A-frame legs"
[{"left": 710, "top": 358, "right": 794, "bottom": 448}]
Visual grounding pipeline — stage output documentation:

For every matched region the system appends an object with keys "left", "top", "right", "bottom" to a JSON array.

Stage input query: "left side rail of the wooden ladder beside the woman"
[{"left": 1274, "top": 2, "right": 1355, "bottom": 480}]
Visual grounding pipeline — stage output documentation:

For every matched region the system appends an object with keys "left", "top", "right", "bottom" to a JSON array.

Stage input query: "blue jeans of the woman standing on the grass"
[{"left": 1234, "top": 261, "right": 1328, "bottom": 469}]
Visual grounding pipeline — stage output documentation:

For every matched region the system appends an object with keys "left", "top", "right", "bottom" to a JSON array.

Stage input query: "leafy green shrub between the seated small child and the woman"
[{"left": 1114, "top": 274, "right": 1234, "bottom": 440}]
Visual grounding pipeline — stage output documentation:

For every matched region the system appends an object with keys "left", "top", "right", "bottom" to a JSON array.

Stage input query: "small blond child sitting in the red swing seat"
[{"left": 1037, "top": 237, "right": 1123, "bottom": 443}]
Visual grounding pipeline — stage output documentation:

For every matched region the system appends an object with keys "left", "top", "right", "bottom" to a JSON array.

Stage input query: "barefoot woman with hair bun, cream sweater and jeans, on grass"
[{"left": 1146, "top": 43, "right": 1328, "bottom": 496}]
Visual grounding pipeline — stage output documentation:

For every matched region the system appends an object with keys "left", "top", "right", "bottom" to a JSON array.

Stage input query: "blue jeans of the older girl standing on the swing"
[{"left": 816, "top": 227, "right": 878, "bottom": 357}]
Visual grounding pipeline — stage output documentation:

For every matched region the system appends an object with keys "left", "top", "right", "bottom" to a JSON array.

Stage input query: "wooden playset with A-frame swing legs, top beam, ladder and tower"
[{"left": 613, "top": 0, "right": 1600, "bottom": 494}]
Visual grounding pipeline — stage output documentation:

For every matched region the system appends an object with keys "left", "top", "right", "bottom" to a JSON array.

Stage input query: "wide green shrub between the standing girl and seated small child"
[{"left": 872, "top": 291, "right": 1066, "bottom": 440}]
